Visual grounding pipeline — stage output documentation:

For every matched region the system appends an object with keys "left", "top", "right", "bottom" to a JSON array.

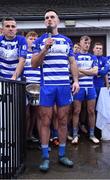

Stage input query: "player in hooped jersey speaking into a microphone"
[{"left": 32, "top": 9, "right": 79, "bottom": 171}]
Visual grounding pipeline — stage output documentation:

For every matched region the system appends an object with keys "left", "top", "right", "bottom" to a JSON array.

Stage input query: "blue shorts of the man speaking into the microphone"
[{"left": 40, "top": 85, "right": 72, "bottom": 107}]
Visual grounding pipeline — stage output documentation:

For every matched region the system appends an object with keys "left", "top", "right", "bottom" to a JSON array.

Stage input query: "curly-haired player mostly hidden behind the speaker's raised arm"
[{"left": 23, "top": 31, "right": 40, "bottom": 142}]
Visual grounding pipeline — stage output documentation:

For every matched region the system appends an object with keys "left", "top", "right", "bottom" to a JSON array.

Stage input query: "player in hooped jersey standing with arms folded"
[{"left": 72, "top": 36, "right": 99, "bottom": 144}]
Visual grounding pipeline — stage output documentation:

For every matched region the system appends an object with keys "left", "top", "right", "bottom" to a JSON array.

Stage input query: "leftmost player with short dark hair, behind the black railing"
[{"left": 0, "top": 17, "right": 27, "bottom": 80}]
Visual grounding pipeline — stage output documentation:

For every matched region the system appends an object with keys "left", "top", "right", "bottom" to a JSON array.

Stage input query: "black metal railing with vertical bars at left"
[{"left": 0, "top": 79, "right": 25, "bottom": 179}]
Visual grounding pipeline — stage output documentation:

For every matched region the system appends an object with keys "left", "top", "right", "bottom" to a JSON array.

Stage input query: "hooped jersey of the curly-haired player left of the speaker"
[{"left": 23, "top": 52, "right": 41, "bottom": 84}]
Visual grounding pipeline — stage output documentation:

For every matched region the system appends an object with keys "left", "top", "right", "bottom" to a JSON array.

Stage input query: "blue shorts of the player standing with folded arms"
[{"left": 73, "top": 88, "right": 97, "bottom": 101}]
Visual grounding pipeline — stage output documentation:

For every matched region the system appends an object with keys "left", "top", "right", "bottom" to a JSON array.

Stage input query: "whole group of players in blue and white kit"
[{"left": 0, "top": 9, "right": 110, "bottom": 172}]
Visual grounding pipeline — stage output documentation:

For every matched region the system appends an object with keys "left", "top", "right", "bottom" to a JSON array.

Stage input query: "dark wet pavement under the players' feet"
[{"left": 18, "top": 135, "right": 110, "bottom": 179}]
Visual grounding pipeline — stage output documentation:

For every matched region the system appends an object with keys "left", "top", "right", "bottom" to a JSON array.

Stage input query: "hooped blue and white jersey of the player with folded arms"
[{"left": 75, "top": 53, "right": 98, "bottom": 88}]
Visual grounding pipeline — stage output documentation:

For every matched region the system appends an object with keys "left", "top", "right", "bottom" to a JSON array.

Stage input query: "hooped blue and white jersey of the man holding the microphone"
[{"left": 33, "top": 33, "right": 73, "bottom": 85}]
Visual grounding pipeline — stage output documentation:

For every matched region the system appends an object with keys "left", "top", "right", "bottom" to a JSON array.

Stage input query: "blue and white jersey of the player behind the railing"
[{"left": 0, "top": 35, "right": 27, "bottom": 79}]
